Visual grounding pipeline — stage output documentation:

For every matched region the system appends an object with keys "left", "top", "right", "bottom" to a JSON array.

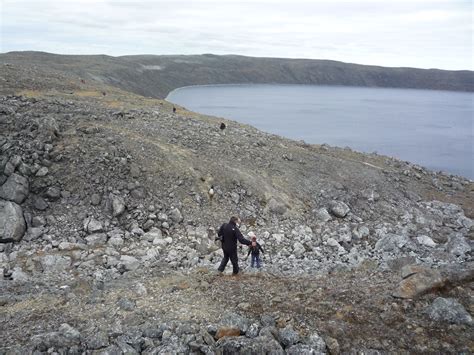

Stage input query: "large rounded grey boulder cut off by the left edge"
[{"left": 0, "top": 200, "right": 26, "bottom": 241}]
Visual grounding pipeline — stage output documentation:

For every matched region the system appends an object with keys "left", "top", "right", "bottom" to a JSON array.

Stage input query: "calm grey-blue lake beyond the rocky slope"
[{"left": 167, "top": 85, "right": 474, "bottom": 179}]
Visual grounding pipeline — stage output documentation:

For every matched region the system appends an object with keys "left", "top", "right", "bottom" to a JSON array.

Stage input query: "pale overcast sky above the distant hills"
[{"left": 0, "top": 0, "right": 474, "bottom": 70}]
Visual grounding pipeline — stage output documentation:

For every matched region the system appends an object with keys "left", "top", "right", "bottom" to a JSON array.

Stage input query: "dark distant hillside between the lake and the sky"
[{"left": 0, "top": 52, "right": 474, "bottom": 98}]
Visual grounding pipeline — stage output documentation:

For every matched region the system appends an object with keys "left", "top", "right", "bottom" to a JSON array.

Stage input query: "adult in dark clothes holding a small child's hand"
[{"left": 217, "top": 217, "right": 252, "bottom": 275}]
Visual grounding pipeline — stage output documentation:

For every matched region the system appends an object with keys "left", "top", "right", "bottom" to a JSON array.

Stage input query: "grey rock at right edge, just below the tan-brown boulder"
[{"left": 427, "top": 297, "right": 474, "bottom": 325}]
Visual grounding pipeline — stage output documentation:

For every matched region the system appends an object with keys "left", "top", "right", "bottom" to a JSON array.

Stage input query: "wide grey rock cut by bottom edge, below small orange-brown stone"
[{"left": 216, "top": 337, "right": 285, "bottom": 355}]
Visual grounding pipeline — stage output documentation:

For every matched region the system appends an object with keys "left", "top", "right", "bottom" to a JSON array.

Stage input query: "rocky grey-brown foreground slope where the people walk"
[{"left": 0, "top": 57, "right": 474, "bottom": 354}]
